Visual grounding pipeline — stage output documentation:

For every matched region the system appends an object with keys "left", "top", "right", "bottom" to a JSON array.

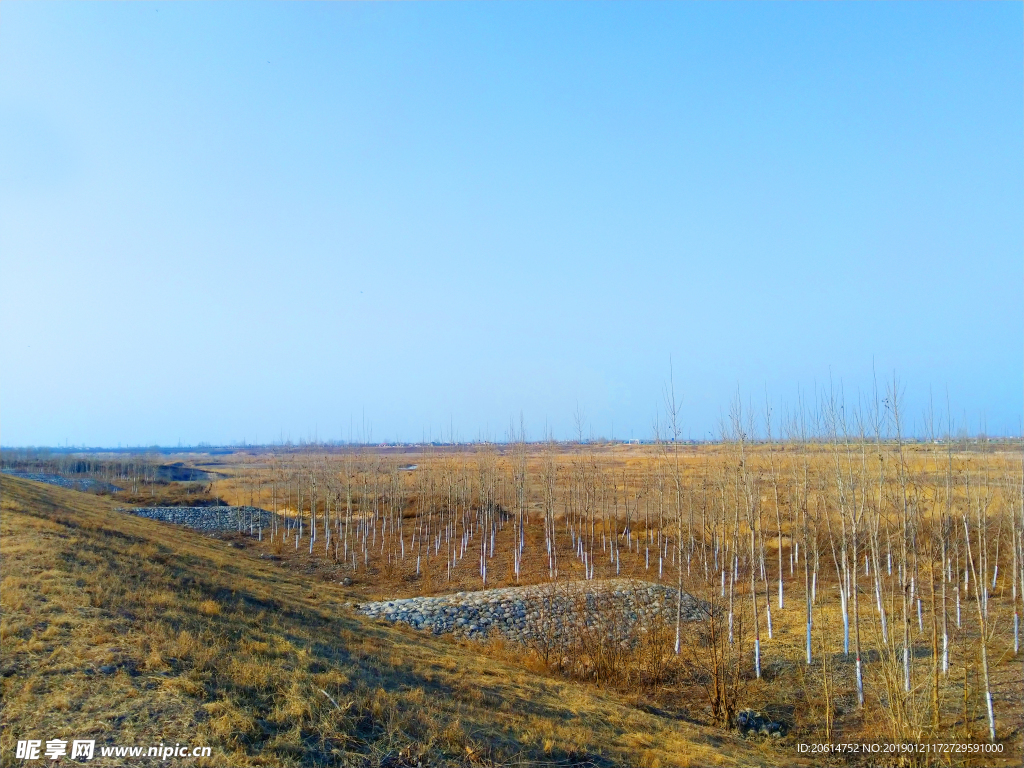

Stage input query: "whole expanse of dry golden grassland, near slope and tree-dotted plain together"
[{"left": 0, "top": 440, "right": 1024, "bottom": 766}]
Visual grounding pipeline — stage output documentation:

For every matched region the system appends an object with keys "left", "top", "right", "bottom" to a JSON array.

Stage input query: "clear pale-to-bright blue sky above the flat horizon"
[{"left": 0, "top": 0, "right": 1024, "bottom": 445}]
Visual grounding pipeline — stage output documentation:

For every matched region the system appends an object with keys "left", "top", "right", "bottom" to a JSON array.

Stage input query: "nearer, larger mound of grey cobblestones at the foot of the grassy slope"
[{"left": 355, "top": 579, "right": 701, "bottom": 644}]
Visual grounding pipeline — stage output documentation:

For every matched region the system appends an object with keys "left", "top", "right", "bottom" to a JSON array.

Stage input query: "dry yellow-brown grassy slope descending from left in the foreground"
[{"left": 0, "top": 477, "right": 782, "bottom": 766}]
